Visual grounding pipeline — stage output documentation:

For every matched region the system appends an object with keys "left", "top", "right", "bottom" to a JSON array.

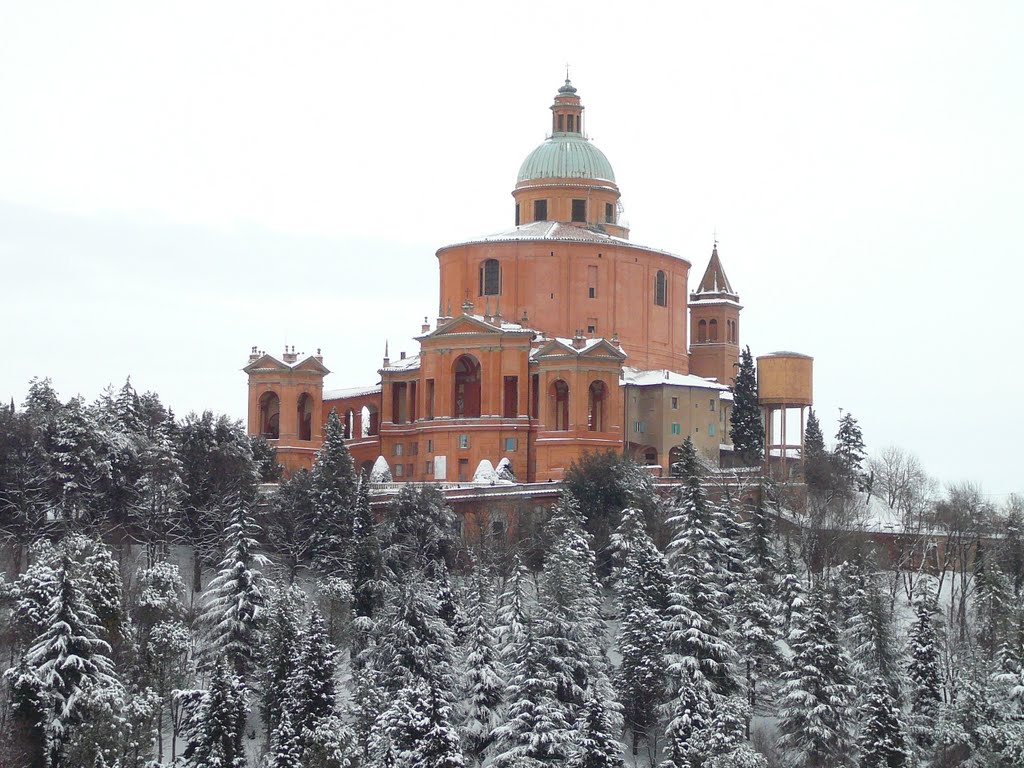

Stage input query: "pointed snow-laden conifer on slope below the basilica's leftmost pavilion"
[{"left": 200, "top": 504, "right": 267, "bottom": 681}]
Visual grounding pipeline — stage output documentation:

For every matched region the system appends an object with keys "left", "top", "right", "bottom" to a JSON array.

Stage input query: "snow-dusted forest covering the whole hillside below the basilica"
[{"left": 0, "top": 381, "right": 1024, "bottom": 768}]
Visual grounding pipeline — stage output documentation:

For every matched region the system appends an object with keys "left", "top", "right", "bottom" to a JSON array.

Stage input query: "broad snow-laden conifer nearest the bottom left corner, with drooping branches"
[{"left": 25, "top": 552, "right": 121, "bottom": 768}]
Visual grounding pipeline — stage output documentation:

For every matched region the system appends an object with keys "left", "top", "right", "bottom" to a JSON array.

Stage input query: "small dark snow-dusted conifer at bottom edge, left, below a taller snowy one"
[{"left": 182, "top": 662, "right": 248, "bottom": 768}]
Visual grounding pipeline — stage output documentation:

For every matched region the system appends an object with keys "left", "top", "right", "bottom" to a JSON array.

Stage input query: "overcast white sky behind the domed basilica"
[{"left": 0, "top": 0, "right": 1024, "bottom": 501}]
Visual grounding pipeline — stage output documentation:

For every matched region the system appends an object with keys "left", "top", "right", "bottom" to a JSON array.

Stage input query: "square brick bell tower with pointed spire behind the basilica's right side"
[{"left": 690, "top": 243, "right": 743, "bottom": 385}]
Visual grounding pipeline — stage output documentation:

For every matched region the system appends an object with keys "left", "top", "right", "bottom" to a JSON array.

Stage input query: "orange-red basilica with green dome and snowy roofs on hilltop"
[{"left": 244, "top": 79, "right": 778, "bottom": 482}]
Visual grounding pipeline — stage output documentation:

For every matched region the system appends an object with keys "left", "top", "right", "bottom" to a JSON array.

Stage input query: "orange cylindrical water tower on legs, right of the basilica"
[{"left": 758, "top": 352, "right": 814, "bottom": 480}]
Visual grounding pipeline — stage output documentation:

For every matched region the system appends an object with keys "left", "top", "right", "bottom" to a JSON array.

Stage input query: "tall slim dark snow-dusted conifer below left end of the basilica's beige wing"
[{"left": 613, "top": 508, "right": 669, "bottom": 756}]
